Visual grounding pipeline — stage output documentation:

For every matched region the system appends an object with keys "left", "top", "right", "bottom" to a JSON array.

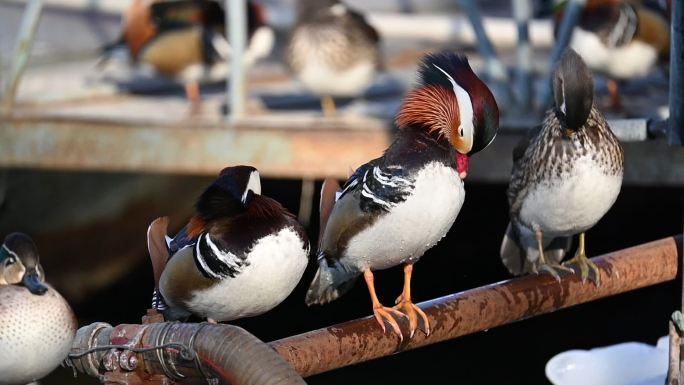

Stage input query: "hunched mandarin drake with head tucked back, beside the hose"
[{"left": 148, "top": 166, "right": 309, "bottom": 322}]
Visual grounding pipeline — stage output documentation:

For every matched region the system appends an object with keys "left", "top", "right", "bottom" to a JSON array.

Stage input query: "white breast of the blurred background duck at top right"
[{"left": 570, "top": 28, "right": 658, "bottom": 79}]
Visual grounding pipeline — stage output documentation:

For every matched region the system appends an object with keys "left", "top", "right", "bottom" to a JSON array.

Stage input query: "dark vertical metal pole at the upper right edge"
[{"left": 667, "top": 0, "right": 684, "bottom": 146}]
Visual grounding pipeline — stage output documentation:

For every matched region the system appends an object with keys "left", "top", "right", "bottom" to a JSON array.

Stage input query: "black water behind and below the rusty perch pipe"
[{"left": 44, "top": 181, "right": 684, "bottom": 384}]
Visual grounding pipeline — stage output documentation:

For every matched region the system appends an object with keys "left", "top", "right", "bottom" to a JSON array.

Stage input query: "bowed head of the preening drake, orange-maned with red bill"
[{"left": 396, "top": 52, "right": 499, "bottom": 176}]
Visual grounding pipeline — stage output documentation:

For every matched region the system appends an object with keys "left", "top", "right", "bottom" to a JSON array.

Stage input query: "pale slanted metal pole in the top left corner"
[{"left": 2, "top": 0, "right": 43, "bottom": 114}]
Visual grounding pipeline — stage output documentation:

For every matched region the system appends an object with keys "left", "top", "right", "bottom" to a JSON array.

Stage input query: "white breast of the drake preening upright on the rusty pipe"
[{"left": 344, "top": 162, "right": 465, "bottom": 270}]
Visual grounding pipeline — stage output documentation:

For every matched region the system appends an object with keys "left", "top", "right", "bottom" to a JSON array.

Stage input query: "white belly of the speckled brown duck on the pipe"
[{"left": 520, "top": 157, "right": 622, "bottom": 236}]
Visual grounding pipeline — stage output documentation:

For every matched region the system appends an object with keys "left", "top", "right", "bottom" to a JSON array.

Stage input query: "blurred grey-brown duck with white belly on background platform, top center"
[{"left": 285, "top": 0, "right": 382, "bottom": 116}]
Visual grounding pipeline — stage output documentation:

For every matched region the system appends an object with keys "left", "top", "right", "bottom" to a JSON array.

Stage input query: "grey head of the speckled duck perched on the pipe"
[{"left": 553, "top": 48, "right": 594, "bottom": 132}]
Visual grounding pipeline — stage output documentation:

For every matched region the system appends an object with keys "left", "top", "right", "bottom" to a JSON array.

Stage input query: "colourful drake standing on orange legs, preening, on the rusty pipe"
[{"left": 306, "top": 53, "right": 499, "bottom": 339}]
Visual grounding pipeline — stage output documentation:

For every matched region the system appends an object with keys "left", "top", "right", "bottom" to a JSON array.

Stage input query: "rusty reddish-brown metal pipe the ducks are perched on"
[{"left": 270, "top": 236, "right": 681, "bottom": 377}]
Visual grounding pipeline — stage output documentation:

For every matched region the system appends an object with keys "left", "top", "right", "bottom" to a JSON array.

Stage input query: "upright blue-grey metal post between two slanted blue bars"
[{"left": 513, "top": 0, "right": 532, "bottom": 110}]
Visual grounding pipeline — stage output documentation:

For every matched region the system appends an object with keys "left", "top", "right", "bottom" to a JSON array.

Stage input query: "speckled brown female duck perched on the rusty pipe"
[{"left": 501, "top": 49, "right": 624, "bottom": 285}]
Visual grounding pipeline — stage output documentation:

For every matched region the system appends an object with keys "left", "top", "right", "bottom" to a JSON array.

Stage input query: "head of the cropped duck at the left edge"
[{"left": 0, "top": 233, "right": 48, "bottom": 295}]
